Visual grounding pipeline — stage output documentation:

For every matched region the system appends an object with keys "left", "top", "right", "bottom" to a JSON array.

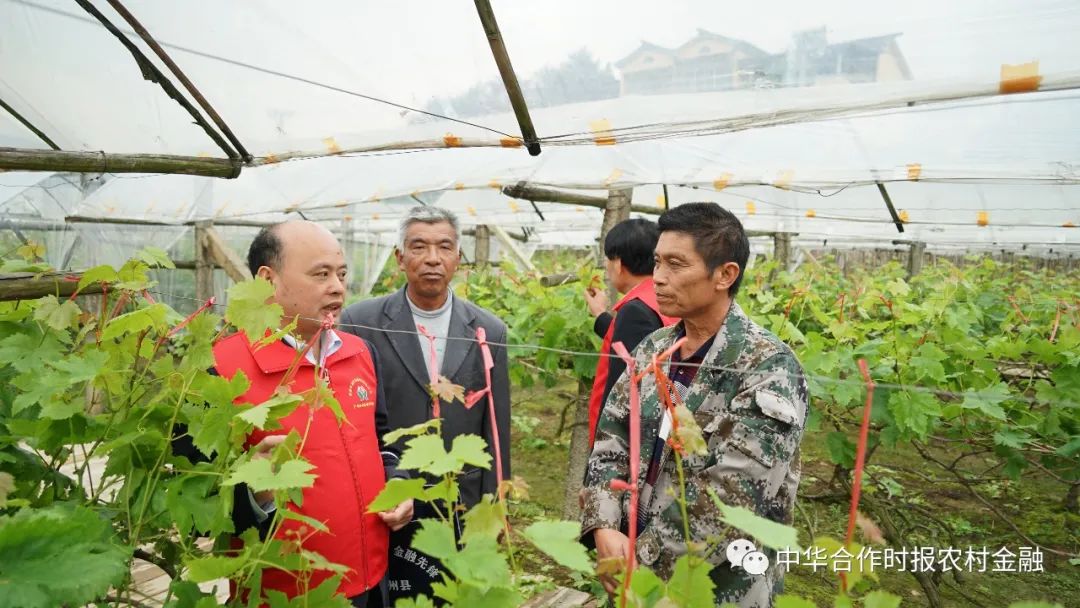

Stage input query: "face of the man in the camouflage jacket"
[{"left": 652, "top": 231, "right": 728, "bottom": 319}]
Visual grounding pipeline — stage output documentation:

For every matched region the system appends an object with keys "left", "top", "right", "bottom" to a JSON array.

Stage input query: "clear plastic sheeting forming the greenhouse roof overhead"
[{"left": 0, "top": 0, "right": 1080, "bottom": 261}]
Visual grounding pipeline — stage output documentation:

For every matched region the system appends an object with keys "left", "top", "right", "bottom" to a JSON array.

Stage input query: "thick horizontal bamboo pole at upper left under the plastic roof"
[{"left": 0, "top": 148, "right": 240, "bottom": 179}]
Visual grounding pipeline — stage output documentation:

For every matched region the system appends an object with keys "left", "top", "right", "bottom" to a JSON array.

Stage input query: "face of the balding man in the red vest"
[{"left": 259, "top": 222, "right": 349, "bottom": 338}]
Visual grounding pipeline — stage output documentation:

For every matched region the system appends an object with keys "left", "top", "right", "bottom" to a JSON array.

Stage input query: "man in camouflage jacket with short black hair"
[{"left": 582, "top": 203, "right": 808, "bottom": 608}]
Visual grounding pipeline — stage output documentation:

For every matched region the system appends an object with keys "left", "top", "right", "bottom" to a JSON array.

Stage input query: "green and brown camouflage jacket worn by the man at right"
[{"left": 582, "top": 302, "right": 808, "bottom": 608}]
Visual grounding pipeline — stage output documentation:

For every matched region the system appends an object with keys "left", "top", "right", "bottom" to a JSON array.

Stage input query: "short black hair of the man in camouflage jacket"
[{"left": 658, "top": 203, "right": 750, "bottom": 298}]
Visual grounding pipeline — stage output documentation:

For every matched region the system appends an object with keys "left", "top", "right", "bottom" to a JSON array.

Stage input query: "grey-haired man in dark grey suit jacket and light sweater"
[{"left": 341, "top": 206, "right": 510, "bottom": 600}]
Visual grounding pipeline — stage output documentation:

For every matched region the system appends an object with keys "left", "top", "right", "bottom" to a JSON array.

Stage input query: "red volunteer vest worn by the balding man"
[{"left": 214, "top": 333, "right": 390, "bottom": 597}]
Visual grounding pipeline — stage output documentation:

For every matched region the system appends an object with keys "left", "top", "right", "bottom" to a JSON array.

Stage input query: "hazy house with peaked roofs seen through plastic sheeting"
[{"left": 615, "top": 27, "right": 912, "bottom": 95}]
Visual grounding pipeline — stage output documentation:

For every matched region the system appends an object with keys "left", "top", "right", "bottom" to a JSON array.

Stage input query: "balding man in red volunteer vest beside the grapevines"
[{"left": 214, "top": 221, "right": 413, "bottom": 607}]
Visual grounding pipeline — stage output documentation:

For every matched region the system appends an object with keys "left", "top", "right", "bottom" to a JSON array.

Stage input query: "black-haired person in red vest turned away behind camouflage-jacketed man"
[{"left": 585, "top": 219, "right": 678, "bottom": 447}]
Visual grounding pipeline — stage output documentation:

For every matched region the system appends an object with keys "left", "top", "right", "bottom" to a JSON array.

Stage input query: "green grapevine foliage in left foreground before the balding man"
[{"left": 0, "top": 257, "right": 356, "bottom": 608}]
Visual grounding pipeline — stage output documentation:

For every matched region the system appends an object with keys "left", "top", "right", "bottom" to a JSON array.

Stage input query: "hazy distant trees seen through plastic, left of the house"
[{"left": 424, "top": 48, "right": 619, "bottom": 118}]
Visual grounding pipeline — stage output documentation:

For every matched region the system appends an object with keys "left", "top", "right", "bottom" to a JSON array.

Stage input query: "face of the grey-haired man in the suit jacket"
[{"left": 396, "top": 221, "right": 460, "bottom": 298}]
